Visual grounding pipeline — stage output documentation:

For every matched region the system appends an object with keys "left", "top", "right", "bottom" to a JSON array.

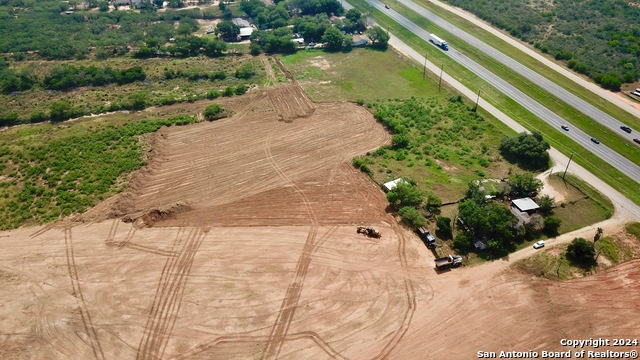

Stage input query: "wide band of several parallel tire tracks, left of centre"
[{"left": 136, "top": 228, "right": 210, "bottom": 360}]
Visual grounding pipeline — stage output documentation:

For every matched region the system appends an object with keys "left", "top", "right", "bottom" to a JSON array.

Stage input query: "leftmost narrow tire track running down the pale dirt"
[{"left": 63, "top": 225, "right": 105, "bottom": 359}]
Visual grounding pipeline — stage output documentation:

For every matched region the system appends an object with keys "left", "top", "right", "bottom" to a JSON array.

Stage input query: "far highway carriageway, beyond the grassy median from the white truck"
[{"left": 398, "top": 0, "right": 640, "bottom": 141}]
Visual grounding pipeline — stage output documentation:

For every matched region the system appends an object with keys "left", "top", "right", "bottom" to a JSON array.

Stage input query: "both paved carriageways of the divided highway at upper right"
[{"left": 367, "top": 0, "right": 640, "bottom": 183}]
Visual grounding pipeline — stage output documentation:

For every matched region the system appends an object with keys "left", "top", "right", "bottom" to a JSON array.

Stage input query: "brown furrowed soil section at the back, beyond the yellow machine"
[{"left": 112, "top": 86, "right": 390, "bottom": 226}]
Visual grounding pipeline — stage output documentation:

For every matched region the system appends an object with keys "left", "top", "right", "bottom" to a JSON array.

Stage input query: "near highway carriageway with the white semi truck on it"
[{"left": 360, "top": 0, "right": 640, "bottom": 183}]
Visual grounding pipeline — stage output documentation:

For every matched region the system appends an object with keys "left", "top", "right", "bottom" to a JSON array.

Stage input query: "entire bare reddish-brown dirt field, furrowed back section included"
[{"left": 0, "top": 84, "right": 640, "bottom": 360}]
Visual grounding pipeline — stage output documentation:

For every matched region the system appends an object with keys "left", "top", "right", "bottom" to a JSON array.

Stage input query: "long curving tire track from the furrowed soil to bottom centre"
[{"left": 262, "top": 131, "right": 318, "bottom": 360}]
